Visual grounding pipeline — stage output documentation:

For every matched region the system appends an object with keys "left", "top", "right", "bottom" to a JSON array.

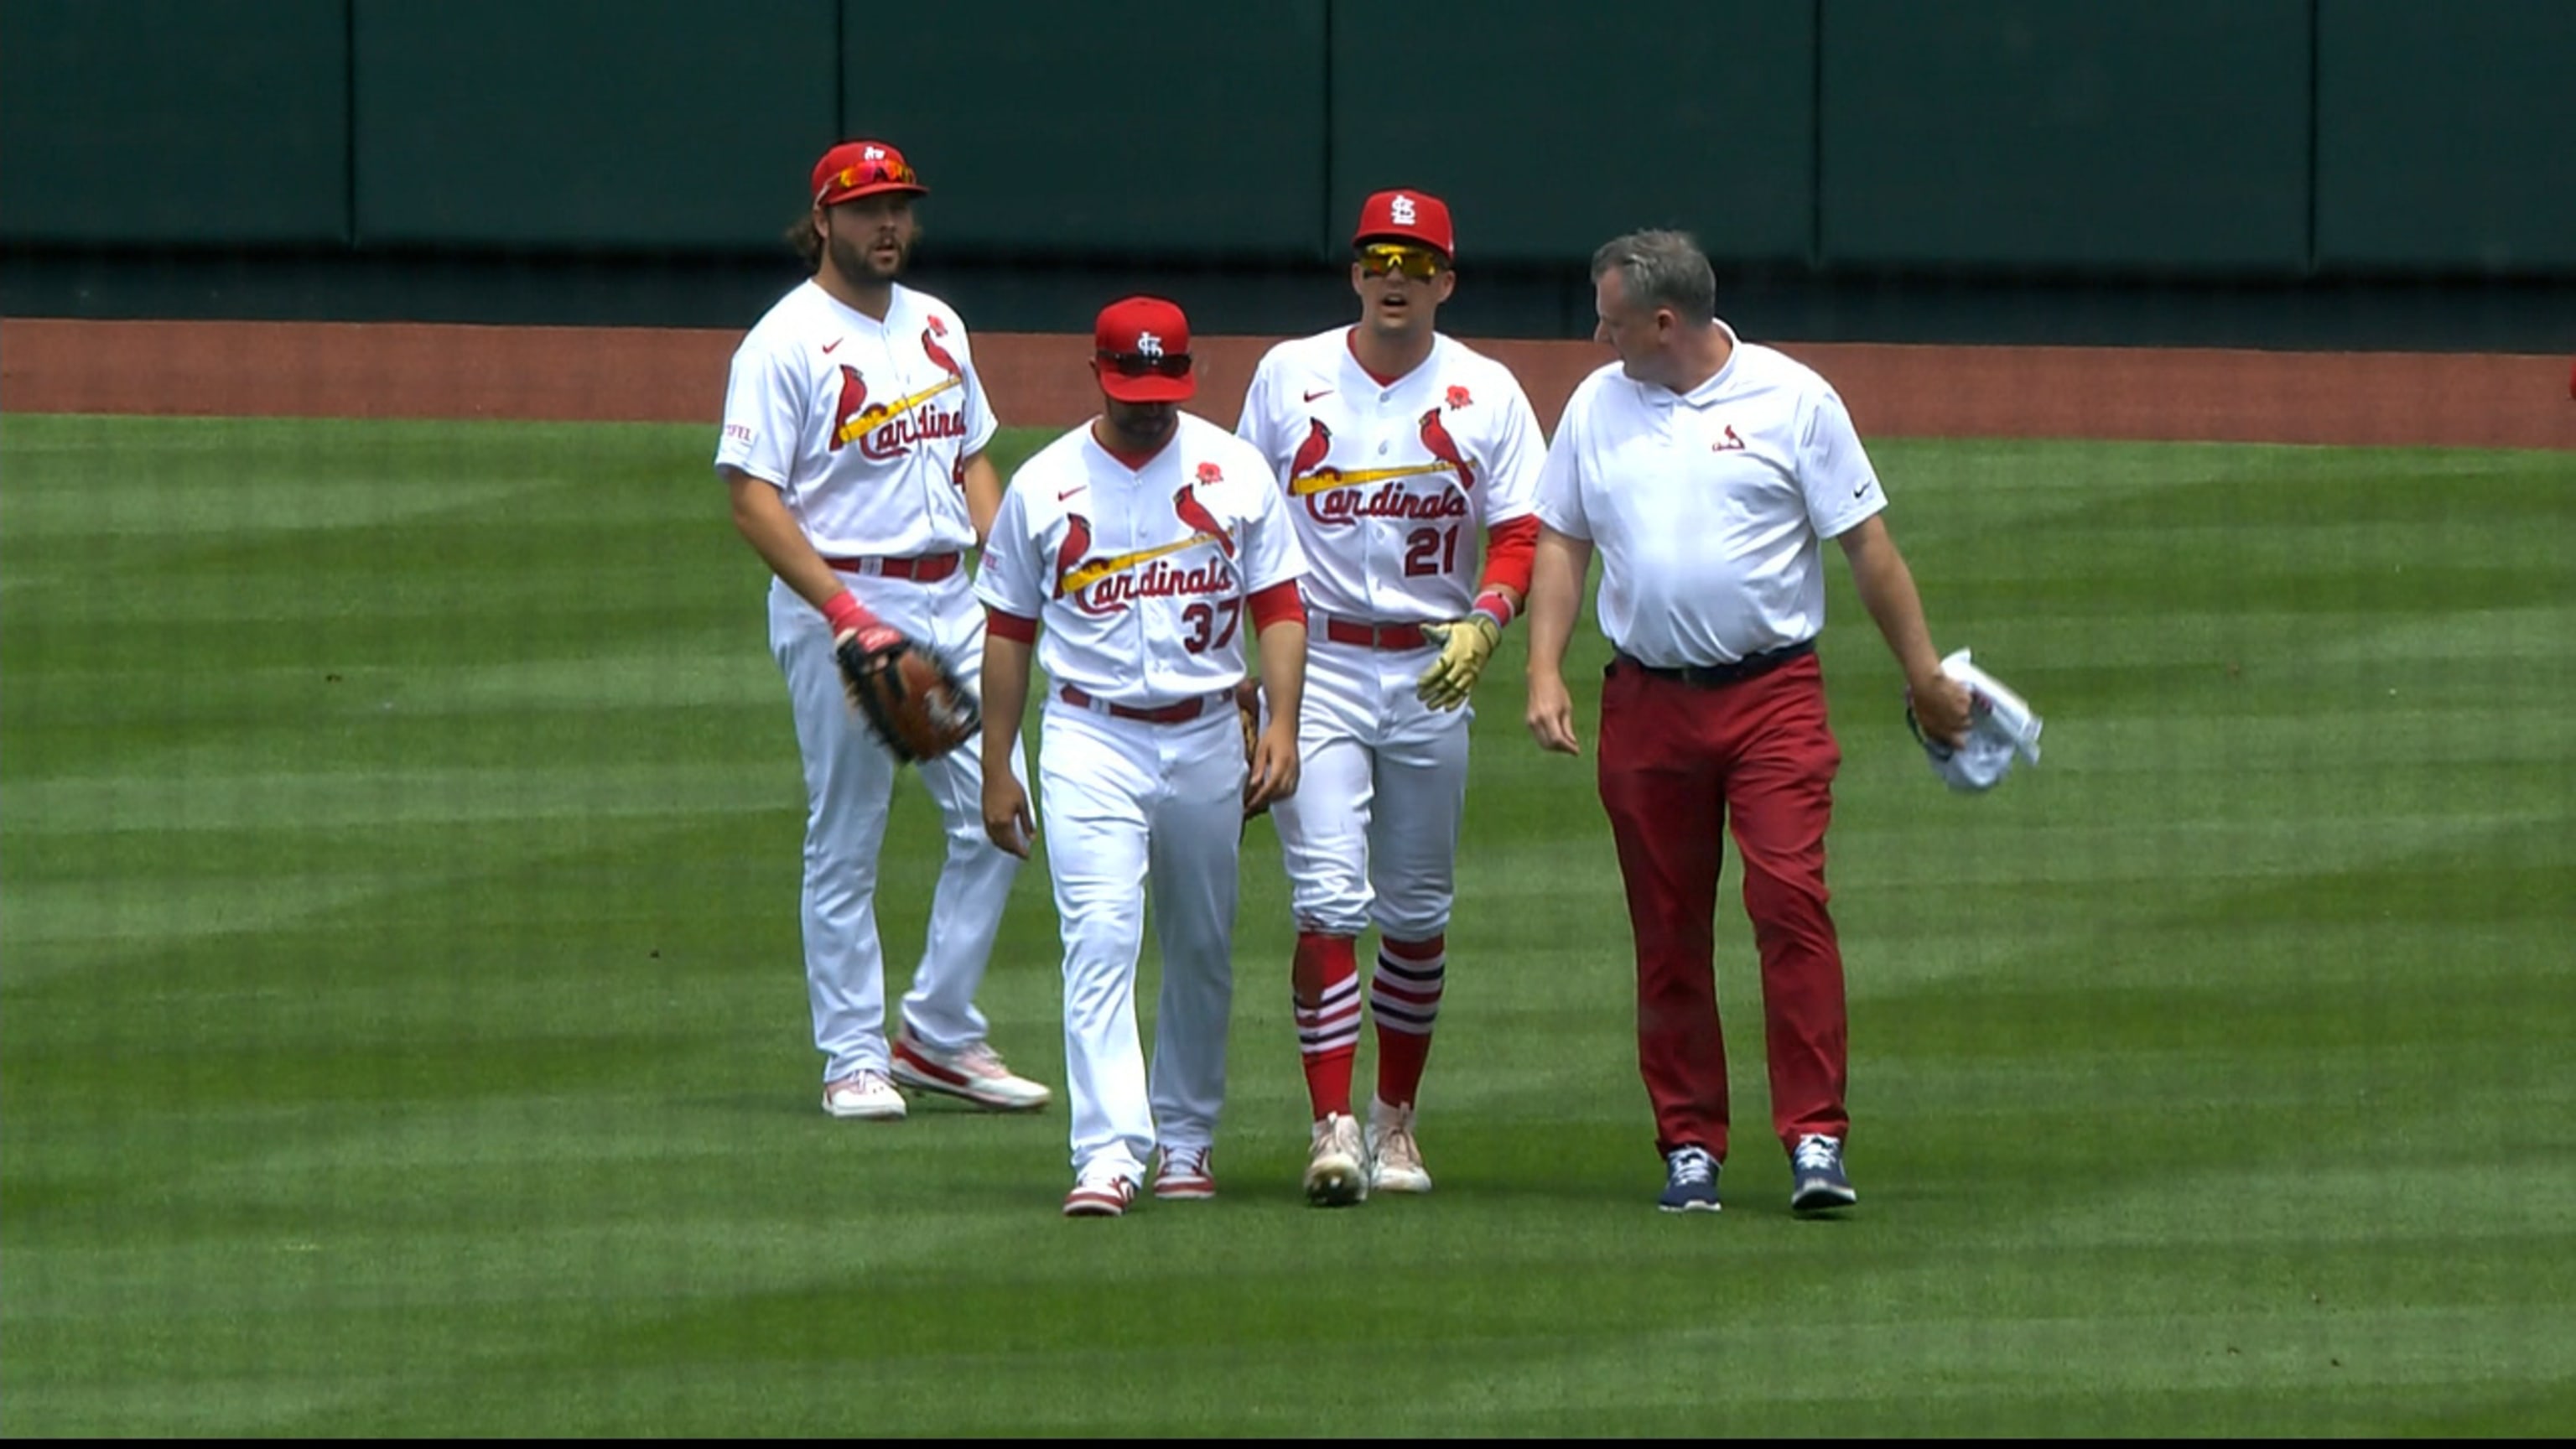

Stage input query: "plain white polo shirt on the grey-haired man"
[{"left": 1538, "top": 322, "right": 1888, "bottom": 667}]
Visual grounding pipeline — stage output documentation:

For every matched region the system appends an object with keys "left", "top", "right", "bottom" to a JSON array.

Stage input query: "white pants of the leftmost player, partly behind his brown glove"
[{"left": 771, "top": 570, "right": 1028, "bottom": 1080}]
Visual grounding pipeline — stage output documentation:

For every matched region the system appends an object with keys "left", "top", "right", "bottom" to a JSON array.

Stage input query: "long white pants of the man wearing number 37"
[{"left": 1038, "top": 688, "right": 1244, "bottom": 1183}]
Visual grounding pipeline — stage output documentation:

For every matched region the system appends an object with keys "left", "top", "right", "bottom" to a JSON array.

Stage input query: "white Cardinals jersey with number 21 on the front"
[{"left": 1233, "top": 327, "right": 1548, "bottom": 624}]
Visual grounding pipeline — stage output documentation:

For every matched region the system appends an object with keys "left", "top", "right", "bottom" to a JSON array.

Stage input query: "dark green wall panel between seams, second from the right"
[{"left": 1821, "top": 0, "right": 2311, "bottom": 273}]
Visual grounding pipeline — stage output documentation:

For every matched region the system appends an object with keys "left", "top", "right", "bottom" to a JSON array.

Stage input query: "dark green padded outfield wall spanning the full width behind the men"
[{"left": 0, "top": 0, "right": 2576, "bottom": 330}]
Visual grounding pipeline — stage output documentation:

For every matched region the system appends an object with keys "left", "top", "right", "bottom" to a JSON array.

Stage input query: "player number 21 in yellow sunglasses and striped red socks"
[{"left": 1237, "top": 191, "right": 1545, "bottom": 1207}]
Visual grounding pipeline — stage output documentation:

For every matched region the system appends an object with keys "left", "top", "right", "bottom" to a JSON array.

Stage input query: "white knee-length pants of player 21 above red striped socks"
[{"left": 1270, "top": 640, "right": 1473, "bottom": 941}]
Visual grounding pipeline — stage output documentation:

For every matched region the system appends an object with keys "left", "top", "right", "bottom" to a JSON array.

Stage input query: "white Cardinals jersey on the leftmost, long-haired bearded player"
[{"left": 716, "top": 281, "right": 997, "bottom": 557}]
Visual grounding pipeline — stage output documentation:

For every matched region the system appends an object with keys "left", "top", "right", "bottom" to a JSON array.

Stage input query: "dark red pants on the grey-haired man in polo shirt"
[{"left": 1600, "top": 655, "right": 1850, "bottom": 1161}]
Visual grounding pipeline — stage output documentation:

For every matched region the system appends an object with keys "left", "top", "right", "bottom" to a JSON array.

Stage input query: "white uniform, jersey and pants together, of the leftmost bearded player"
[{"left": 716, "top": 281, "right": 1026, "bottom": 1080}]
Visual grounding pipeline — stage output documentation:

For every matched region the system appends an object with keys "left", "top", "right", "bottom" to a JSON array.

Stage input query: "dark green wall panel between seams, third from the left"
[{"left": 843, "top": 0, "right": 1324, "bottom": 261}]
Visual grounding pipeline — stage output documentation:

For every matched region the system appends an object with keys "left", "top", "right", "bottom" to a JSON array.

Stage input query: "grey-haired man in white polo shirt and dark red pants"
[{"left": 1528, "top": 232, "right": 1968, "bottom": 1212}]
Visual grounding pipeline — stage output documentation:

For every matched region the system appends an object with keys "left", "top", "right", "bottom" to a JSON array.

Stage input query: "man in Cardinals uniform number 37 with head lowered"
[{"left": 976, "top": 297, "right": 1306, "bottom": 1217}]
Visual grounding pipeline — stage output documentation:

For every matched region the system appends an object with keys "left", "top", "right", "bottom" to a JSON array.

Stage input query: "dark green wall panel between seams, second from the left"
[{"left": 353, "top": 0, "right": 837, "bottom": 250}]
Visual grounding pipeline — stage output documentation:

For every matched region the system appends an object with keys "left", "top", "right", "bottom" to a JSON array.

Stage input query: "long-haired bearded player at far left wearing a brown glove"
[{"left": 716, "top": 142, "right": 1048, "bottom": 1119}]
